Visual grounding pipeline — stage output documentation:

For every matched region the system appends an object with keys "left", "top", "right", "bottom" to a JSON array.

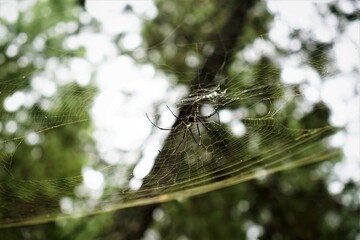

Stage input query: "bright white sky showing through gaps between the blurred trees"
[{"left": 0, "top": 1, "right": 360, "bottom": 198}]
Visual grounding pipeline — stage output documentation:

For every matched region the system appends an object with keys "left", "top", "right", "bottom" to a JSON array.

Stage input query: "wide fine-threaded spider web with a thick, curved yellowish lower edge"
[{"left": 0, "top": 1, "right": 344, "bottom": 227}]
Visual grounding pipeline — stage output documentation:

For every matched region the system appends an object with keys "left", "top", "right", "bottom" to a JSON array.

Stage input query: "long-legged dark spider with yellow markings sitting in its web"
[{"left": 146, "top": 103, "right": 220, "bottom": 153}]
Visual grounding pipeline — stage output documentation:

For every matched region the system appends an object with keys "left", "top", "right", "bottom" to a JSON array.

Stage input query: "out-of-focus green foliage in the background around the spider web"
[{"left": 0, "top": 0, "right": 360, "bottom": 239}]
